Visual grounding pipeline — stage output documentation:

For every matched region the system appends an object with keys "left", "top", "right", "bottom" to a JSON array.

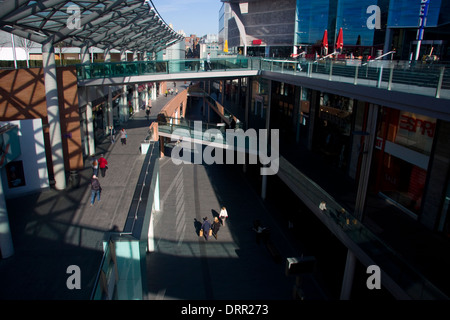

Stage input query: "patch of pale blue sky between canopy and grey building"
[{"left": 152, "top": 0, "right": 222, "bottom": 37}]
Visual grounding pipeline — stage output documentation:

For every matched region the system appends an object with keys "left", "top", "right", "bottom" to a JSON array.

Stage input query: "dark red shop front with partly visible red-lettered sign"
[{"left": 372, "top": 108, "right": 436, "bottom": 218}]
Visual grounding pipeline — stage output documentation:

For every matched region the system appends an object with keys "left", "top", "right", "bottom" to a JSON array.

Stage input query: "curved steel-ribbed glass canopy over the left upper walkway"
[{"left": 0, "top": 0, "right": 183, "bottom": 52}]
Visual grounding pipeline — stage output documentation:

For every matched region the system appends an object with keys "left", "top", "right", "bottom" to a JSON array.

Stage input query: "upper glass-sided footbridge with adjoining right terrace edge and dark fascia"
[{"left": 76, "top": 56, "right": 450, "bottom": 121}]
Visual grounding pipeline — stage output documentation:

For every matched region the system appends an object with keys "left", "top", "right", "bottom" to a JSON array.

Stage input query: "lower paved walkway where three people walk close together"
[{"left": 147, "top": 94, "right": 327, "bottom": 300}]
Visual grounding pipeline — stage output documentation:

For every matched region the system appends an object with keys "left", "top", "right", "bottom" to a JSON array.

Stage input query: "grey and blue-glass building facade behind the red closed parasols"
[{"left": 219, "top": 0, "right": 449, "bottom": 60}]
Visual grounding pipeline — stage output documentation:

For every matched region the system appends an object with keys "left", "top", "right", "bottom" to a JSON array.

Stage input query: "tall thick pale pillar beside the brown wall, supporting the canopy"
[{"left": 42, "top": 43, "right": 66, "bottom": 190}]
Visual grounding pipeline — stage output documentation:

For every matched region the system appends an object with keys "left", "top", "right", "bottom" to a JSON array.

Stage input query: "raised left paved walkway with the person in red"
[{"left": 0, "top": 83, "right": 179, "bottom": 300}]
